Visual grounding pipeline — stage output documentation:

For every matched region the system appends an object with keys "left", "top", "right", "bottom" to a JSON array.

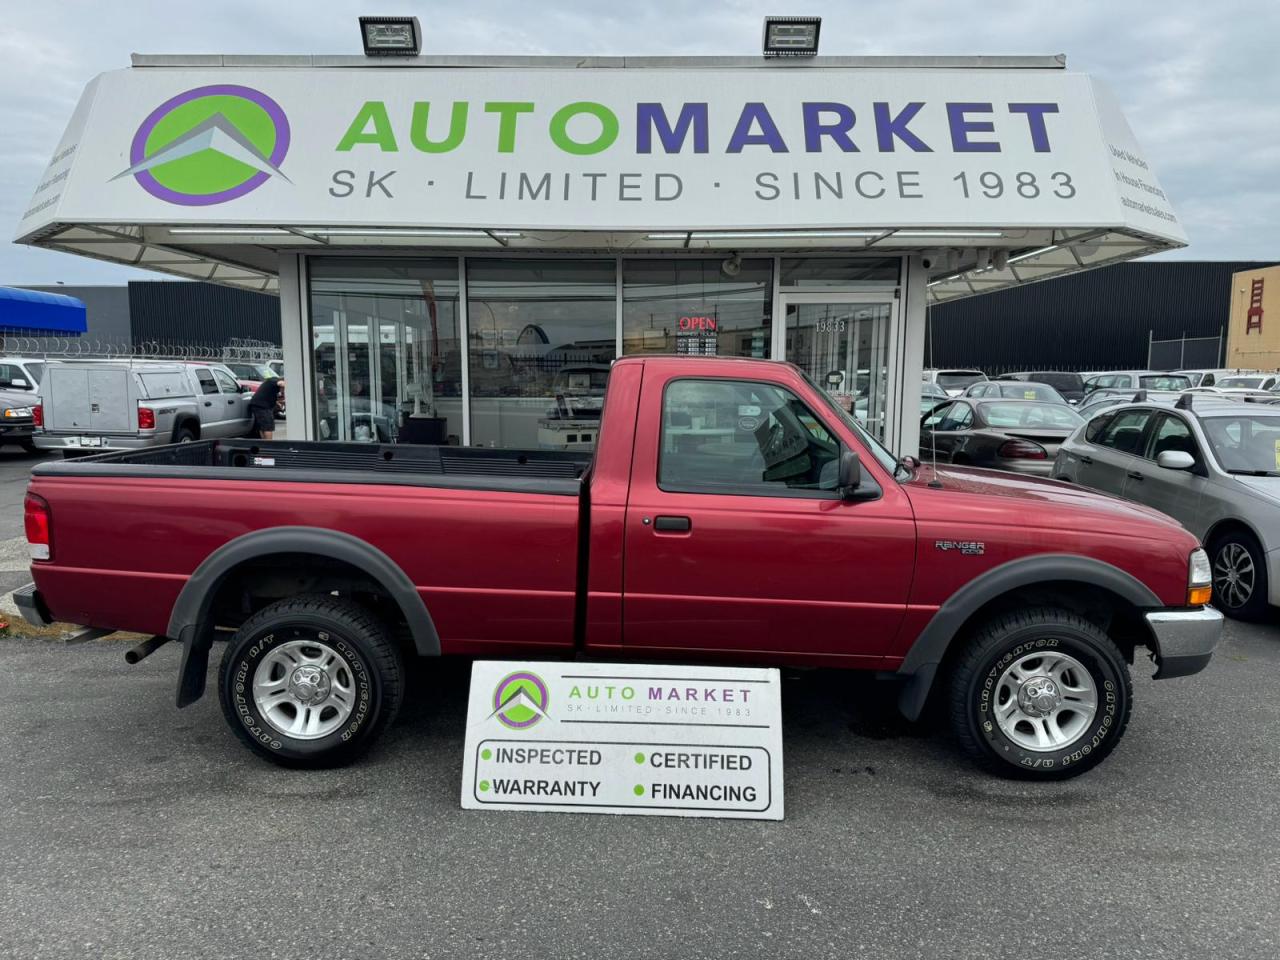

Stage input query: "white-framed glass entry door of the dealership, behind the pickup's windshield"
[{"left": 782, "top": 293, "right": 897, "bottom": 439}]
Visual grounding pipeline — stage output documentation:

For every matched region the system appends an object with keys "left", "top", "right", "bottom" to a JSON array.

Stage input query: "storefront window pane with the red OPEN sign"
[{"left": 622, "top": 257, "right": 773, "bottom": 358}]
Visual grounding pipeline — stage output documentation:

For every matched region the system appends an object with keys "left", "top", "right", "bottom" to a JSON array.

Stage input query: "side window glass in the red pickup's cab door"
[{"left": 658, "top": 380, "right": 840, "bottom": 497}]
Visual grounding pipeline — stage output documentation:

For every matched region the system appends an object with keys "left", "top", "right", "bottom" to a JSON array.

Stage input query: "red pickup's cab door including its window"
[{"left": 624, "top": 367, "right": 915, "bottom": 666}]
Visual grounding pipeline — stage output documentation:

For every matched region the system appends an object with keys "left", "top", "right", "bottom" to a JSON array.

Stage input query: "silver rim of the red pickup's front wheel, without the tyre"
[{"left": 992, "top": 650, "right": 1098, "bottom": 753}]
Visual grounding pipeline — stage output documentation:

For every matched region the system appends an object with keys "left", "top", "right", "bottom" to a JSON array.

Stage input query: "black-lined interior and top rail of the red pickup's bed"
[{"left": 33, "top": 439, "right": 591, "bottom": 495}]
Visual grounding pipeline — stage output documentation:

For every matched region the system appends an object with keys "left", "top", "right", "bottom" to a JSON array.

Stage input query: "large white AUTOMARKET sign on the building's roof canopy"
[{"left": 19, "top": 68, "right": 1183, "bottom": 242}]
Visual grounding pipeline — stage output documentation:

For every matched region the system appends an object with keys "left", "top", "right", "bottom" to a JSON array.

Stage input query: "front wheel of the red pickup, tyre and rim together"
[{"left": 948, "top": 607, "right": 1133, "bottom": 780}]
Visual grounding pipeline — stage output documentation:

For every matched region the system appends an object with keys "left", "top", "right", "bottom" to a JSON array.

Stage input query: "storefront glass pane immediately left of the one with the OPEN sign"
[{"left": 467, "top": 259, "right": 617, "bottom": 451}]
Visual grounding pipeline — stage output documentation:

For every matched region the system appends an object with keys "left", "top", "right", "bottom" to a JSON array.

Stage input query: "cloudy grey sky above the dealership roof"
[{"left": 0, "top": 0, "right": 1280, "bottom": 284}]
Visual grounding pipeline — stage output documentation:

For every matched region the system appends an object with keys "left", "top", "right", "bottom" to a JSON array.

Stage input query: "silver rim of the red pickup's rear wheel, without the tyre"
[{"left": 253, "top": 640, "right": 356, "bottom": 740}]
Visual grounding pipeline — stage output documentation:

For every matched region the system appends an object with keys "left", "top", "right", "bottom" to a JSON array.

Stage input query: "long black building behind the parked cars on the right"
[{"left": 924, "top": 260, "right": 1274, "bottom": 374}]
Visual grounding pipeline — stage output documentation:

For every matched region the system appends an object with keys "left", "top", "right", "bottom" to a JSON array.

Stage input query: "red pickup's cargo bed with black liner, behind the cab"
[{"left": 31, "top": 439, "right": 589, "bottom": 653}]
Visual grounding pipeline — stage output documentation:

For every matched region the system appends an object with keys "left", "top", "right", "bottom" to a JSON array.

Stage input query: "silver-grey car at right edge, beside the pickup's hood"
[{"left": 1053, "top": 394, "right": 1280, "bottom": 620}]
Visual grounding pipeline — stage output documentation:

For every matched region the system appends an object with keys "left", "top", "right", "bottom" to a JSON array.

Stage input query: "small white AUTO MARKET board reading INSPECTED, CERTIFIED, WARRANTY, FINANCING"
[{"left": 462, "top": 660, "right": 783, "bottom": 820}]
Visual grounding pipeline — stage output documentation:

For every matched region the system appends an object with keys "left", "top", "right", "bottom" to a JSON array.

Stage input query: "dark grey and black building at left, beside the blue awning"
[{"left": 8, "top": 280, "right": 280, "bottom": 355}]
